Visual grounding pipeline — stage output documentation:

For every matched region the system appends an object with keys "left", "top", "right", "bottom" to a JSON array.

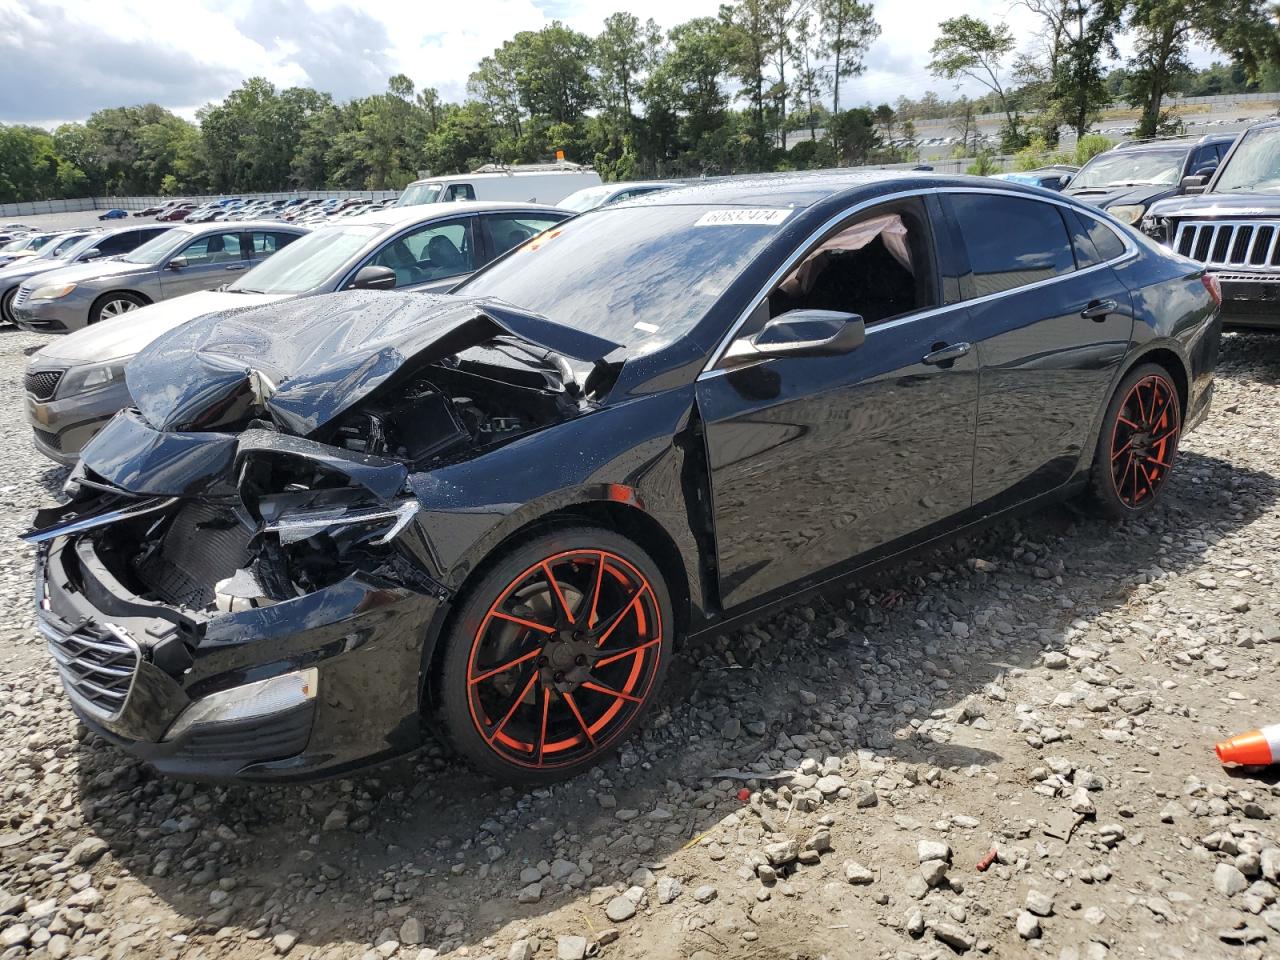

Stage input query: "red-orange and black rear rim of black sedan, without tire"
[{"left": 1111, "top": 375, "right": 1181, "bottom": 509}]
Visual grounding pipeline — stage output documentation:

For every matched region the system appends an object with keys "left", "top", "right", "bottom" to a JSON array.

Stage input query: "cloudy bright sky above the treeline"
[{"left": 0, "top": 0, "right": 1211, "bottom": 125}]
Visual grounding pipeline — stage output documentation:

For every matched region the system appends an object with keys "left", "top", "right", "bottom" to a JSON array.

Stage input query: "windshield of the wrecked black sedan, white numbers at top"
[{"left": 454, "top": 205, "right": 791, "bottom": 353}]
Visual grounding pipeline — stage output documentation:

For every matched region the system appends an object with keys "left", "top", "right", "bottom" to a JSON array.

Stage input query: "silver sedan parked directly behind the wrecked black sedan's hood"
[{"left": 18, "top": 204, "right": 570, "bottom": 463}]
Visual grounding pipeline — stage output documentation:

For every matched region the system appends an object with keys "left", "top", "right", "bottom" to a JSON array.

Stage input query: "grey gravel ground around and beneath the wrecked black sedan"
[{"left": 0, "top": 332, "right": 1280, "bottom": 960}]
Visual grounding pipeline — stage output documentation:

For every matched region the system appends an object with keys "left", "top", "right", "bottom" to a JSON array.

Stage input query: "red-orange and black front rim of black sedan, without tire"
[{"left": 467, "top": 549, "right": 663, "bottom": 769}]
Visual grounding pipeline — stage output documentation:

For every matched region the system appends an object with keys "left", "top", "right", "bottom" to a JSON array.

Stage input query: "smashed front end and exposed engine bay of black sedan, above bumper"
[{"left": 27, "top": 294, "right": 611, "bottom": 626}]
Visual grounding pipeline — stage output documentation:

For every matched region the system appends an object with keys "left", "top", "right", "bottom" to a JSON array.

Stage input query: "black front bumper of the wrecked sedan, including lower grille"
[{"left": 36, "top": 527, "right": 439, "bottom": 780}]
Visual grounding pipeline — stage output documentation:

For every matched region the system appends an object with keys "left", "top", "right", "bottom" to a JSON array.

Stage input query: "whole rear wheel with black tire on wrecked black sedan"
[{"left": 1088, "top": 364, "right": 1181, "bottom": 520}]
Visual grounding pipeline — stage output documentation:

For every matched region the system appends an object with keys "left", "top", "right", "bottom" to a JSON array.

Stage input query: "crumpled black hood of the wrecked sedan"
[{"left": 125, "top": 291, "right": 618, "bottom": 435}]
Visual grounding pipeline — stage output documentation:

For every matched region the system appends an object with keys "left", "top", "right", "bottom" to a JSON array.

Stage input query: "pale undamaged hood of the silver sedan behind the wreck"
[{"left": 38, "top": 291, "right": 290, "bottom": 364}]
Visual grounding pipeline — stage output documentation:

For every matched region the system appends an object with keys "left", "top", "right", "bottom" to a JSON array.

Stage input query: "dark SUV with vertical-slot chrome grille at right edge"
[{"left": 1142, "top": 120, "right": 1280, "bottom": 330}]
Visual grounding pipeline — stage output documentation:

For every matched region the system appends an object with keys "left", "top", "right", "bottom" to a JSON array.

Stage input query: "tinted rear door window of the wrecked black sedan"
[{"left": 945, "top": 193, "right": 1075, "bottom": 297}]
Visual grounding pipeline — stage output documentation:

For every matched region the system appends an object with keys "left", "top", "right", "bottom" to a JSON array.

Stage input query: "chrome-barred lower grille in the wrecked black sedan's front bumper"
[{"left": 40, "top": 622, "right": 138, "bottom": 719}]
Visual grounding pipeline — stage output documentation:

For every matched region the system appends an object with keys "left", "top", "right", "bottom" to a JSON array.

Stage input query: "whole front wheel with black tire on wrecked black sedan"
[{"left": 435, "top": 526, "right": 675, "bottom": 785}]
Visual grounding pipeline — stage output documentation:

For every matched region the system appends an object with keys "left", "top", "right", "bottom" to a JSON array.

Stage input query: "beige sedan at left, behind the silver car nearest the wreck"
[{"left": 12, "top": 223, "right": 307, "bottom": 333}]
